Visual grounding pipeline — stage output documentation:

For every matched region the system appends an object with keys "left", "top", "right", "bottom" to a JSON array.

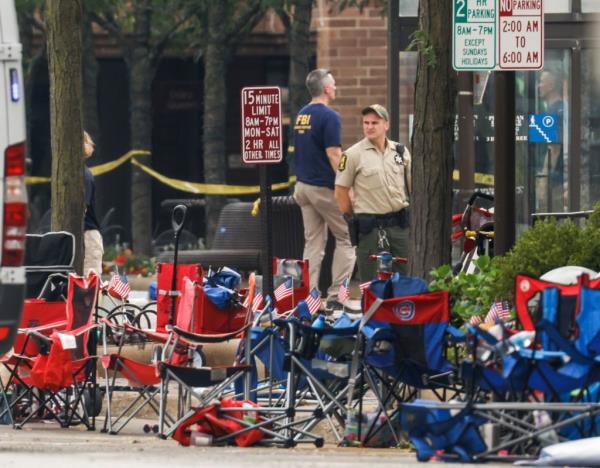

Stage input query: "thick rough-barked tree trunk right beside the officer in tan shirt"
[{"left": 409, "top": 0, "right": 456, "bottom": 277}]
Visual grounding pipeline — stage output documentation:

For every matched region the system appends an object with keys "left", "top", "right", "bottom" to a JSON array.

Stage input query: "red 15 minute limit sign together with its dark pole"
[{"left": 241, "top": 86, "right": 283, "bottom": 297}]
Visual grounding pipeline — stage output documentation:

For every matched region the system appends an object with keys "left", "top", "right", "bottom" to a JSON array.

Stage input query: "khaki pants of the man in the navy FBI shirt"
[{"left": 294, "top": 182, "right": 356, "bottom": 300}]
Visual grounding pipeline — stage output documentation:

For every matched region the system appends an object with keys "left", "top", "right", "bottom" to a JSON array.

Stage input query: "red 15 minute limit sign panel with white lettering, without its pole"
[{"left": 242, "top": 86, "right": 283, "bottom": 164}]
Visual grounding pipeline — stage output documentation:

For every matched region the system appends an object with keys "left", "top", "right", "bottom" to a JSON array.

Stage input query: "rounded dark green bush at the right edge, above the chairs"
[{"left": 494, "top": 203, "right": 600, "bottom": 299}]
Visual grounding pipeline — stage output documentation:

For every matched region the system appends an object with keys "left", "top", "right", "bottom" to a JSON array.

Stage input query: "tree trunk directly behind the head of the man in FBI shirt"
[{"left": 288, "top": 0, "right": 313, "bottom": 173}]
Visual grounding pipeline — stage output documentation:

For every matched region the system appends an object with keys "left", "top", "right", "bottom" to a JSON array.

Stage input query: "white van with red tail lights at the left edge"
[{"left": 0, "top": 0, "right": 27, "bottom": 355}]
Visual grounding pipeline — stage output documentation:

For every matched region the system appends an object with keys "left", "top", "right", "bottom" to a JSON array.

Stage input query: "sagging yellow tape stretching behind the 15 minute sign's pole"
[{"left": 131, "top": 158, "right": 296, "bottom": 195}]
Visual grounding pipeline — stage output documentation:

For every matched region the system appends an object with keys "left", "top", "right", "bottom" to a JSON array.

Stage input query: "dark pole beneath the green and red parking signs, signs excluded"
[{"left": 494, "top": 71, "right": 516, "bottom": 255}]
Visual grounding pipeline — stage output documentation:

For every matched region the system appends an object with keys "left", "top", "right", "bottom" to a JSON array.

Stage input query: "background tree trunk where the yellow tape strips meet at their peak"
[{"left": 127, "top": 0, "right": 155, "bottom": 255}]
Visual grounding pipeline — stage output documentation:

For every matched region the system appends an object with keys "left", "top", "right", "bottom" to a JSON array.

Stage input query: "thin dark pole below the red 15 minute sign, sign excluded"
[{"left": 259, "top": 164, "right": 273, "bottom": 298}]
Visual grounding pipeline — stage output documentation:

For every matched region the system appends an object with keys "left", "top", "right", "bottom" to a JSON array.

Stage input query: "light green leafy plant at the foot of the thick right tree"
[{"left": 429, "top": 255, "right": 499, "bottom": 326}]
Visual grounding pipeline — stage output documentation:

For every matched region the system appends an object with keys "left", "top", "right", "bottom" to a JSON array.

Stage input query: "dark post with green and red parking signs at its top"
[{"left": 453, "top": 0, "right": 544, "bottom": 255}]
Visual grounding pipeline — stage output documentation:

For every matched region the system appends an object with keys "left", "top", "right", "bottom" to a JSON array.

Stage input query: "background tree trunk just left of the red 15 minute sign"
[{"left": 202, "top": 2, "right": 229, "bottom": 247}]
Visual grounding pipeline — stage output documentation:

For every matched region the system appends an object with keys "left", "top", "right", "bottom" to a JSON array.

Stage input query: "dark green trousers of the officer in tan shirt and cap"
[{"left": 356, "top": 226, "right": 408, "bottom": 283}]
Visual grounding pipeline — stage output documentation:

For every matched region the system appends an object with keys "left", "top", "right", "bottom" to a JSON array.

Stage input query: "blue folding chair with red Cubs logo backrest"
[{"left": 346, "top": 275, "right": 464, "bottom": 444}]
